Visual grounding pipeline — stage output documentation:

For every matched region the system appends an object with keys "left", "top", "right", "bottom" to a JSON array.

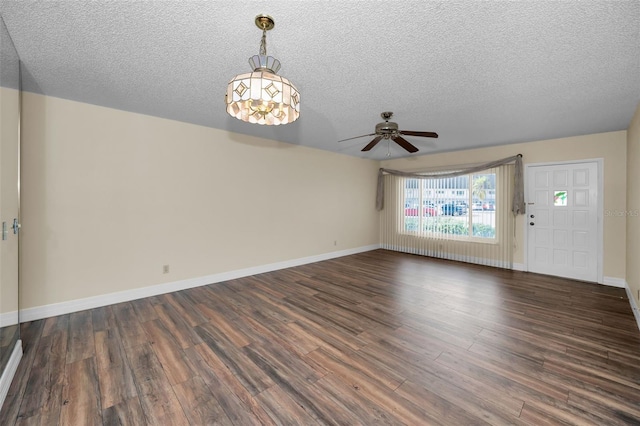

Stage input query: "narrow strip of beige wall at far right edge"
[{"left": 626, "top": 103, "right": 640, "bottom": 302}]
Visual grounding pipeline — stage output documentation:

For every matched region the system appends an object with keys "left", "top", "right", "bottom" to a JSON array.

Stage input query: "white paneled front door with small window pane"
[{"left": 526, "top": 162, "right": 602, "bottom": 282}]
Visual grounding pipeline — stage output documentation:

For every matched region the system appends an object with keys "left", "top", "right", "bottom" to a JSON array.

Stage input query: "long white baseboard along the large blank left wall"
[{"left": 20, "top": 244, "right": 380, "bottom": 322}]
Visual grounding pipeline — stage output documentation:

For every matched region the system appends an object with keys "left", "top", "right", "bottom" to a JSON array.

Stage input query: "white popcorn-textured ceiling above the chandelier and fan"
[{"left": 0, "top": 0, "right": 640, "bottom": 159}]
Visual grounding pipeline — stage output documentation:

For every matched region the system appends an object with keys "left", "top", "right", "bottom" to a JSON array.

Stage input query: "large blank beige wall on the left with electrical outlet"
[{"left": 21, "top": 93, "right": 379, "bottom": 309}]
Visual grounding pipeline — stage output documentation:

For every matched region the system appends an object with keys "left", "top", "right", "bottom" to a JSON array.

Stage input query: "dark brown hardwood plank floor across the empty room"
[{"left": 0, "top": 250, "right": 640, "bottom": 425}]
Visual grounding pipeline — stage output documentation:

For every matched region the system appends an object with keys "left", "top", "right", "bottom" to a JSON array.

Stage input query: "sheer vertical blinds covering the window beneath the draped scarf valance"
[{"left": 380, "top": 164, "right": 515, "bottom": 268}]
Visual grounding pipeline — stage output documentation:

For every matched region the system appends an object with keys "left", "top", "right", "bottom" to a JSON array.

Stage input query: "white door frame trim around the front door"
[{"left": 522, "top": 158, "right": 604, "bottom": 284}]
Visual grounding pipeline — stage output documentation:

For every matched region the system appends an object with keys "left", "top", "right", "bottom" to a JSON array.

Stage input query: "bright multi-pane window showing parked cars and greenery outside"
[{"left": 400, "top": 170, "right": 497, "bottom": 241}]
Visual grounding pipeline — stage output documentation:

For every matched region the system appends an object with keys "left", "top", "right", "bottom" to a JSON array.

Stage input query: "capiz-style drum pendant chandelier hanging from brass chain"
[{"left": 225, "top": 15, "right": 300, "bottom": 126}]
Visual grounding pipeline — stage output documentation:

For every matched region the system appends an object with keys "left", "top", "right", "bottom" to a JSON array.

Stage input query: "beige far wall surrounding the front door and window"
[{"left": 382, "top": 131, "right": 627, "bottom": 279}]
